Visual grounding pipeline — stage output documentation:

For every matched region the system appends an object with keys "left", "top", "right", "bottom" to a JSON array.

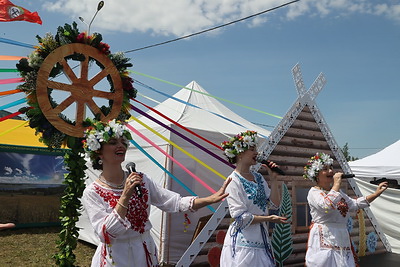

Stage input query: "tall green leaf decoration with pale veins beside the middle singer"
[{"left": 271, "top": 184, "right": 293, "bottom": 266}]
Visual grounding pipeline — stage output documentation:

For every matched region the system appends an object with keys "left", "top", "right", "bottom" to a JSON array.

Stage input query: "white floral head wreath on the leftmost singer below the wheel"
[{"left": 82, "top": 119, "right": 132, "bottom": 160}]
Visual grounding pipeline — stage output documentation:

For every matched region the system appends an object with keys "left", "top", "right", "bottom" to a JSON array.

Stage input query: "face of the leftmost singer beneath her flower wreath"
[{"left": 100, "top": 137, "right": 128, "bottom": 165}]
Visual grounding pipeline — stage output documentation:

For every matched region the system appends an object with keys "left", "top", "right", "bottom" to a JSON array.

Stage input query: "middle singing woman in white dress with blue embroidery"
[{"left": 220, "top": 131, "right": 288, "bottom": 267}]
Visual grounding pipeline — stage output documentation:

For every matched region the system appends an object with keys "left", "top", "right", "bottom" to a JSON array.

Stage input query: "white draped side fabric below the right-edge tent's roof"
[{"left": 355, "top": 179, "right": 400, "bottom": 254}]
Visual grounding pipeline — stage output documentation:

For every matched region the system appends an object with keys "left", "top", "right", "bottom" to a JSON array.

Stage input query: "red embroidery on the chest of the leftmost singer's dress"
[{"left": 94, "top": 182, "right": 149, "bottom": 234}]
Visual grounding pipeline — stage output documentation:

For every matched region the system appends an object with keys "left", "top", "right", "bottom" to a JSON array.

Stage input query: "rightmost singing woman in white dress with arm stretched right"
[{"left": 304, "top": 153, "right": 388, "bottom": 267}]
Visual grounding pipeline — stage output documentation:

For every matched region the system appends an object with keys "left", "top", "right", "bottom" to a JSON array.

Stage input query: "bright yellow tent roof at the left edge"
[{"left": 0, "top": 119, "right": 46, "bottom": 147}]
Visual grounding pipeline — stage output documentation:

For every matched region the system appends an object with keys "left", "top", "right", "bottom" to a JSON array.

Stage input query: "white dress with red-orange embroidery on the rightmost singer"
[{"left": 306, "top": 187, "right": 369, "bottom": 267}]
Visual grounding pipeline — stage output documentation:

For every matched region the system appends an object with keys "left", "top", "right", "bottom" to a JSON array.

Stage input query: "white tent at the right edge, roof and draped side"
[{"left": 349, "top": 140, "right": 400, "bottom": 253}]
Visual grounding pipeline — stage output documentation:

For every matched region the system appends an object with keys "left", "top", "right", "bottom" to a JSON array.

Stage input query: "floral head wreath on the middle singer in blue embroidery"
[{"left": 221, "top": 130, "right": 257, "bottom": 163}]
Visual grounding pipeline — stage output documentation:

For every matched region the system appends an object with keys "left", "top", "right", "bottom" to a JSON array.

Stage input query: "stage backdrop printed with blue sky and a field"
[{"left": 0, "top": 144, "right": 66, "bottom": 227}]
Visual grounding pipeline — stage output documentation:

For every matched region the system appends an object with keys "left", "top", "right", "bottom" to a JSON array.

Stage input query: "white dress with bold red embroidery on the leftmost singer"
[{"left": 82, "top": 175, "right": 195, "bottom": 267}]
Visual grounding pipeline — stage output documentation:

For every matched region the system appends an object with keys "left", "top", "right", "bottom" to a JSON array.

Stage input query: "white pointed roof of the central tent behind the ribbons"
[{"left": 132, "top": 81, "right": 270, "bottom": 136}]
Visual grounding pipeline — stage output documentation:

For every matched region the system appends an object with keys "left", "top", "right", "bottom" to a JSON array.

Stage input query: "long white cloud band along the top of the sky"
[{"left": 43, "top": 0, "right": 400, "bottom": 36}]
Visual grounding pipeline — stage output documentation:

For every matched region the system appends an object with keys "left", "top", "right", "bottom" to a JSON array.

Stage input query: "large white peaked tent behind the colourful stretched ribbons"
[{"left": 78, "top": 81, "right": 270, "bottom": 263}]
